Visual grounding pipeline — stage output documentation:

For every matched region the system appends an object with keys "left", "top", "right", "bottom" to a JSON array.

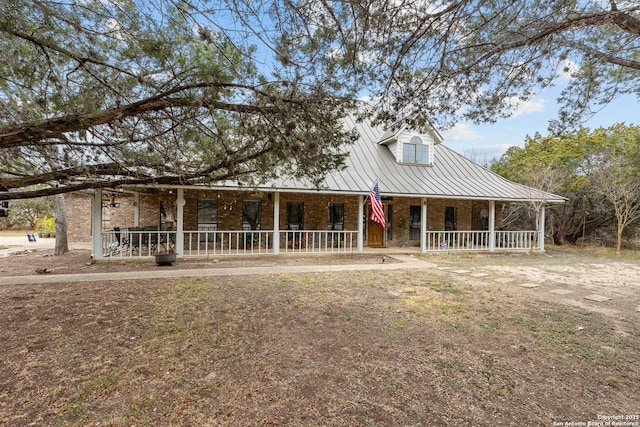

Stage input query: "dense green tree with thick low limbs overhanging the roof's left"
[{"left": 0, "top": 0, "right": 351, "bottom": 199}]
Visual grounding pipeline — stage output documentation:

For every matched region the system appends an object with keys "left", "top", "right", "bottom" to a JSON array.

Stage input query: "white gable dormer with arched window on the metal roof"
[{"left": 378, "top": 125, "right": 442, "bottom": 165}]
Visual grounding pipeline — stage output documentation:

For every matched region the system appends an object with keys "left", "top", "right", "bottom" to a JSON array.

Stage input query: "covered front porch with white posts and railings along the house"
[{"left": 91, "top": 188, "right": 544, "bottom": 259}]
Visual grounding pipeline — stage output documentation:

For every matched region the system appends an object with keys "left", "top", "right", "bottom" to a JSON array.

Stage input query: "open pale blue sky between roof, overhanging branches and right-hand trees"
[{"left": 440, "top": 86, "right": 640, "bottom": 164}]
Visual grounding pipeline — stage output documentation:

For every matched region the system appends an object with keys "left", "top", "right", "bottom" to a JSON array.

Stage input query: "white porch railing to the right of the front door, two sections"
[{"left": 426, "top": 231, "right": 540, "bottom": 251}]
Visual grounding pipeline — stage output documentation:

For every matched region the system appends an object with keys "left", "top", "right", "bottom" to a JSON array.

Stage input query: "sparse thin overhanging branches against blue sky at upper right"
[{"left": 249, "top": 0, "right": 640, "bottom": 130}]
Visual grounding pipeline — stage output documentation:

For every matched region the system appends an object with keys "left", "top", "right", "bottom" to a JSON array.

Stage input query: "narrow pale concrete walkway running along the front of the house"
[{"left": 0, "top": 254, "right": 436, "bottom": 285}]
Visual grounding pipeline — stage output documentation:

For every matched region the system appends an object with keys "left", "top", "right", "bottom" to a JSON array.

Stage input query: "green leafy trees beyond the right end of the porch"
[{"left": 492, "top": 124, "right": 640, "bottom": 249}]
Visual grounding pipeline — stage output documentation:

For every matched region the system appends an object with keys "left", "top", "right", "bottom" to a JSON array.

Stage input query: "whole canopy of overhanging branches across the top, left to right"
[{"left": 5, "top": 0, "right": 640, "bottom": 204}]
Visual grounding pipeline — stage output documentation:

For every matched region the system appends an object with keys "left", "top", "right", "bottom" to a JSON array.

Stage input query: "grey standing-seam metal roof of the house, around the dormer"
[{"left": 268, "top": 117, "right": 566, "bottom": 203}]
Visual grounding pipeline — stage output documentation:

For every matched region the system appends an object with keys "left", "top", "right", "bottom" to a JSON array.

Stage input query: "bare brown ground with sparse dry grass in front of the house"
[{"left": 0, "top": 246, "right": 640, "bottom": 426}]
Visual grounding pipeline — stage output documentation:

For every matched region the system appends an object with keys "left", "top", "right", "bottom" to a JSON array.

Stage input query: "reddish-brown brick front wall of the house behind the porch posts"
[{"left": 65, "top": 190, "right": 500, "bottom": 246}]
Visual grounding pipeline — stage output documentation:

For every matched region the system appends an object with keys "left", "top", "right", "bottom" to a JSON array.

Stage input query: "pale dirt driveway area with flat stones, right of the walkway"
[{"left": 430, "top": 250, "right": 640, "bottom": 319}]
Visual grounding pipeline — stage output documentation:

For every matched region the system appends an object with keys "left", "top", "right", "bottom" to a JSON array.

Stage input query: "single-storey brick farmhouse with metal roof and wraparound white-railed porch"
[{"left": 66, "top": 117, "right": 564, "bottom": 258}]
